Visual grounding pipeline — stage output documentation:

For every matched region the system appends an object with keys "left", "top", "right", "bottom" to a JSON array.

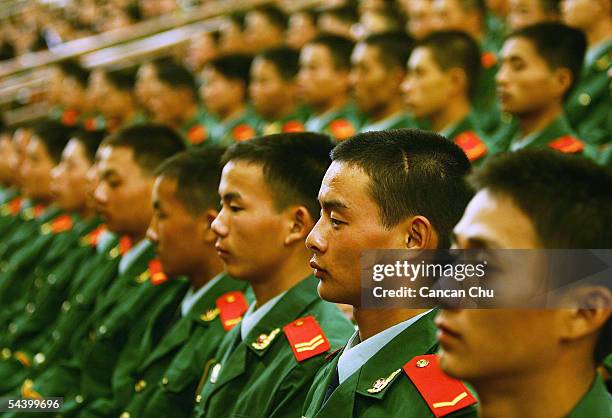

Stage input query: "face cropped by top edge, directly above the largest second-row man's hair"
[{"left": 506, "top": 0, "right": 561, "bottom": 30}]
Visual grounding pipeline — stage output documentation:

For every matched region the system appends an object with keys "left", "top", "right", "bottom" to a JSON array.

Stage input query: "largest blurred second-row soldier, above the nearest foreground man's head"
[{"left": 493, "top": 23, "right": 586, "bottom": 154}]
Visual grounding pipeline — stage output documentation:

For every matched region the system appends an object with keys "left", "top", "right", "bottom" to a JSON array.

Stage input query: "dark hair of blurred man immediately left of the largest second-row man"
[{"left": 417, "top": 30, "right": 481, "bottom": 99}]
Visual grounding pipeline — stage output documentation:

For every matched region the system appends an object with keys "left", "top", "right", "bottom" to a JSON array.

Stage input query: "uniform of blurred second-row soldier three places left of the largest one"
[{"left": 305, "top": 102, "right": 363, "bottom": 141}]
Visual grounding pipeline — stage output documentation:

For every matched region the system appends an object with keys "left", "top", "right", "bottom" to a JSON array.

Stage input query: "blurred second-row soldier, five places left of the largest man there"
[{"left": 199, "top": 54, "right": 259, "bottom": 146}]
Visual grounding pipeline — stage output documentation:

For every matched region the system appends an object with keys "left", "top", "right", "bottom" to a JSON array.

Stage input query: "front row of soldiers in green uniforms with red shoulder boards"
[{"left": 0, "top": 116, "right": 612, "bottom": 418}]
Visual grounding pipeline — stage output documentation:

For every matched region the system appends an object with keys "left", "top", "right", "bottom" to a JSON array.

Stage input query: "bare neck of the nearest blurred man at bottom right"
[{"left": 470, "top": 361, "right": 595, "bottom": 418}]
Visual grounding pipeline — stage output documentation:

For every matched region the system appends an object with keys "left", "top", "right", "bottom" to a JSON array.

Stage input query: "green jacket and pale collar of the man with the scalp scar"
[{"left": 302, "top": 310, "right": 477, "bottom": 418}]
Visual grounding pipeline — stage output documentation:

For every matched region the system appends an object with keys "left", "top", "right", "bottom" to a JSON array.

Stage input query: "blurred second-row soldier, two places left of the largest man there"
[{"left": 350, "top": 33, "right": 416, "bottom": 132}]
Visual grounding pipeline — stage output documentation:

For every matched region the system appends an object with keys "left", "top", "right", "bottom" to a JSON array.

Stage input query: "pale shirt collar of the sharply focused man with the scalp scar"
[{"left": 338, "top": 309, "right": 432, "bottom": 384}]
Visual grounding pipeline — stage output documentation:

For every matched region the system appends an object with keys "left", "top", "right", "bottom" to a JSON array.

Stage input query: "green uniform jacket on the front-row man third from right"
[{"left": 195, "top": 276, "right": 354, "bottom": 418}]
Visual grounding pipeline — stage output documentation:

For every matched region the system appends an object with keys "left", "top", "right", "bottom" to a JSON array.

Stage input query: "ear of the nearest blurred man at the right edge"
[{"left": 560, "top": 286, "right": 612, "bottom": 341}]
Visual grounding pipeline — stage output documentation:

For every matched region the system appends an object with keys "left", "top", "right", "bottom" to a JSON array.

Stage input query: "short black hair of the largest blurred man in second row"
[{"left": 507, "top": 22, "right": 587, "bottom": 96}]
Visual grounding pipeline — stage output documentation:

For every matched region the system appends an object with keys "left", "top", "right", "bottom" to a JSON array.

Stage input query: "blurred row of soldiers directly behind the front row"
[{"left": 44, "top": 0, "right": 612, "bottom": 164}]
